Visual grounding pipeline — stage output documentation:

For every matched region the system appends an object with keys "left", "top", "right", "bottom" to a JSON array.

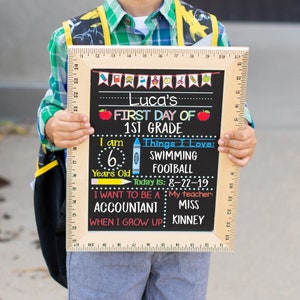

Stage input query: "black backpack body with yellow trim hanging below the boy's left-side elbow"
[{"left": 33, "top": 145, "right": 67, "bottom": 288}]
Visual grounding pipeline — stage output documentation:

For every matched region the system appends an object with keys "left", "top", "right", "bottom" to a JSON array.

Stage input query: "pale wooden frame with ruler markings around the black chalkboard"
[{"left": 67, "top": 46, "right": 249, "bottom": 252}]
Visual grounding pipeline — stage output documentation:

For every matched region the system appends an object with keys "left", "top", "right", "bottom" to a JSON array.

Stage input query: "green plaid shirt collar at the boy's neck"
[{"left": 103, "top": 0, "right": 176, "bottom": 32}]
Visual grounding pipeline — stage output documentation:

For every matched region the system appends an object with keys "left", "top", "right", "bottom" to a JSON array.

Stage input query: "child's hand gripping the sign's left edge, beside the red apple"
[{"left": 45, "top": 110, "right": 94, "bottom": 148}]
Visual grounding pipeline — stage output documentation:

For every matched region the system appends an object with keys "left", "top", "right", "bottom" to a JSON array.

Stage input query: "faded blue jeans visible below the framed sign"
[{"left": 67, "top": 252, "right": 210, "bottom": 300}]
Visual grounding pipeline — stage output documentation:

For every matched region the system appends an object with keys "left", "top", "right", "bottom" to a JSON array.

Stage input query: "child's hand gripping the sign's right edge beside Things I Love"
[{"left": 218, "top": 124, "right": 257, "bottom": 167}]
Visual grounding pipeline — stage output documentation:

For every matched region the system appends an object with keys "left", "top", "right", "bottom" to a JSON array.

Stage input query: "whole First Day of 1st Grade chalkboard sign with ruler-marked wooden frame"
[{"left": 67, "top": 46, "right": 248, "bottom": 251}]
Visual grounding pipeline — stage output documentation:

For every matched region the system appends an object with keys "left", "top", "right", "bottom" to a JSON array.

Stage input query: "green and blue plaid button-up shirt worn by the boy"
[{"left": 38, "top": 0, "right": 251, "bottom": 150}]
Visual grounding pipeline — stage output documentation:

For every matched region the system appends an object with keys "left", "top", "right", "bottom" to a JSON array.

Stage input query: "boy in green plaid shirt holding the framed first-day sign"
[{"left": 38, "top": 0, "right": 256, "bottom": 300}]
